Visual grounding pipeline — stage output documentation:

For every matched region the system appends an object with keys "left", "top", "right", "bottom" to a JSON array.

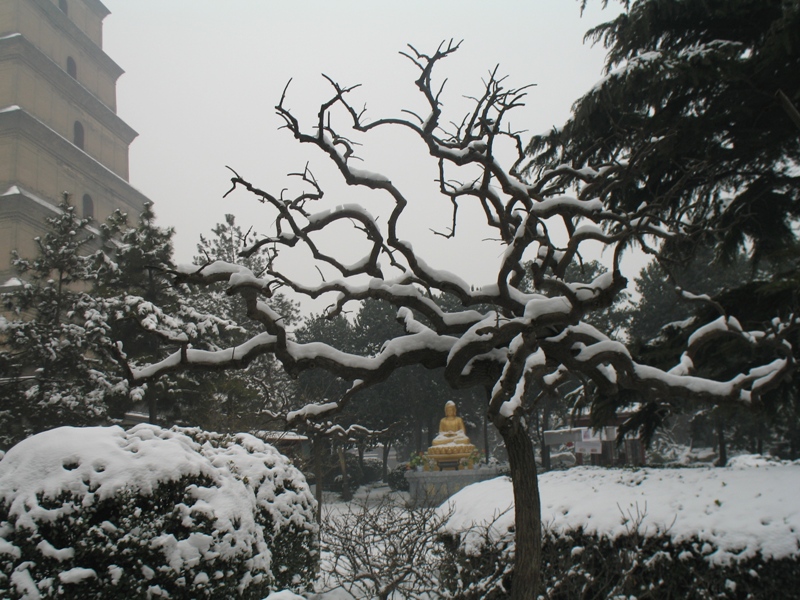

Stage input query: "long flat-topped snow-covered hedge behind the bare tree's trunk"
[{"left": 442, "top": 456, "right": 800, "bottom": 600}]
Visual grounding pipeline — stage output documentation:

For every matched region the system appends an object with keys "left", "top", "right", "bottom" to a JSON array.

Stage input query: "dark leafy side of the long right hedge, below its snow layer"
[{"left": 443, "top": 531, "right": 800, "bottom": 600}]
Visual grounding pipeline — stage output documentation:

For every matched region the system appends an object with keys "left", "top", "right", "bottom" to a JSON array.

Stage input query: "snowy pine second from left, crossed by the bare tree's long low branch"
[{"left": 94, "top": 203, "right": 242, "bottom": 426}]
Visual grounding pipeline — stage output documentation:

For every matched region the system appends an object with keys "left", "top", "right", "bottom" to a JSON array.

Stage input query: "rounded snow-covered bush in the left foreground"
[{"left": 0, "top": 425, "right": 318, "bottom": 600}]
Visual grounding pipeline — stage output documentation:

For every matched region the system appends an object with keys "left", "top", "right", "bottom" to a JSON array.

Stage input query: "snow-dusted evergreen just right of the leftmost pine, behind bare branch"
[{"left": 95, "top": 203, "right": 268, "bottom": 431}]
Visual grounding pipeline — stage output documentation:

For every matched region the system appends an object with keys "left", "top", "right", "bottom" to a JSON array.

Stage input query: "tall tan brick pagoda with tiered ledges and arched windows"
[{"left": 0, "top": 0, "right": 148, "bottom": 285}]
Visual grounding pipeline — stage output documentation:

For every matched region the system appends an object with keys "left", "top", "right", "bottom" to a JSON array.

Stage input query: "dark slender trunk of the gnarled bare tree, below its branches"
[{"left": 500, "top": 419, "right": 542, "bottom": 600}]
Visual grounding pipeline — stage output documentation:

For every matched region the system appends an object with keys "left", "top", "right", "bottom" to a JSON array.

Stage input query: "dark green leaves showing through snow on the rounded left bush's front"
[{"left": 0, "top": 477, "right": 241, "bottom": 600}]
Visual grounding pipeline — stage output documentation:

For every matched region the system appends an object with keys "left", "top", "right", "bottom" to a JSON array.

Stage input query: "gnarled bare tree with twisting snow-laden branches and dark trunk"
[{"left": 131, "top": 43, "right": 796, "bottom": 599}]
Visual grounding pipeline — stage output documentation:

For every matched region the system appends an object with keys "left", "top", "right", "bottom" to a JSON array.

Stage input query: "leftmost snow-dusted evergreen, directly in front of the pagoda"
[{"left": 0, "top": 195, "right": 127, "bottom": 446}]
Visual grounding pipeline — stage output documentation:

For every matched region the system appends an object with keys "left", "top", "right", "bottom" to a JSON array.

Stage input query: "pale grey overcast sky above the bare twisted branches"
[{"left": 98, "top": 0, "right": 617, "bottom": 314}]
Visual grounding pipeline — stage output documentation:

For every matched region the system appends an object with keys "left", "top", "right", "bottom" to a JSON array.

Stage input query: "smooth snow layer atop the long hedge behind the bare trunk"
[{"left": 440, "top": 455, "right": 800, "bottom": 564}]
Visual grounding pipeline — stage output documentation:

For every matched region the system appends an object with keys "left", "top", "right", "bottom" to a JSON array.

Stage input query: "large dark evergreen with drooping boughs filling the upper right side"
[{"left": 528, "top": 0, "right": 800, "bottom": 462}]
